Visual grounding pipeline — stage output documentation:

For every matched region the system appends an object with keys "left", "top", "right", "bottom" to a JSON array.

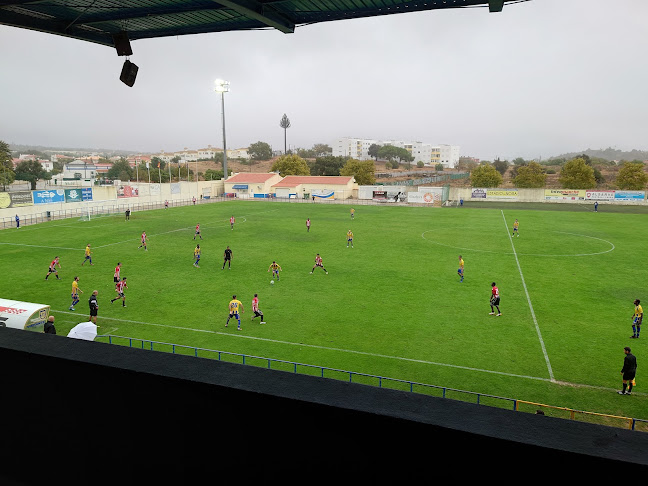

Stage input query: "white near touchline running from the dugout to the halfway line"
[{"left": 51, "top": 310, "right": 553, "bottom": 382}]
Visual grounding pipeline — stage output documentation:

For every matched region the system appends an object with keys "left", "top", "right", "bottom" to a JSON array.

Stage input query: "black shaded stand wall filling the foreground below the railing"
[{"left": 0, "top": 329, "right": 648, "bottom": 485}]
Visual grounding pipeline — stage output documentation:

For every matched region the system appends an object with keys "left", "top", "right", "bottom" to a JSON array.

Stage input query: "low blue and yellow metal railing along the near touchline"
[{"left": 97, "top": 334, "right": 648, "bottom": 432}]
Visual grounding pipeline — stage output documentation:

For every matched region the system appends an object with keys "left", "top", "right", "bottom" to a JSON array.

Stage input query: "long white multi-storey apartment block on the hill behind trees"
[{"left": 333, "top": 137, "right": 459, "bottom": 169}]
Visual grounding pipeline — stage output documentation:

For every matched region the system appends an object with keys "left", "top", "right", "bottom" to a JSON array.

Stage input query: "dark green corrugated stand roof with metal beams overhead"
[{"left": 0, "top": 0, "right": 529, "bottom": 48}]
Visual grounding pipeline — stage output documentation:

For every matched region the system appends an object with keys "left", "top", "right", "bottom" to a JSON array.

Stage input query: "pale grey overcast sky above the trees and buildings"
[{"left": 0, "top": 0, "right": 648, "bottom": 160}]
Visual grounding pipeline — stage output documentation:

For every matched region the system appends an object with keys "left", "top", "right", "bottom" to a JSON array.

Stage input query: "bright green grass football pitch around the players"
[{"left": 0, "top": 201, "right": 648, "bottom": 419}]
